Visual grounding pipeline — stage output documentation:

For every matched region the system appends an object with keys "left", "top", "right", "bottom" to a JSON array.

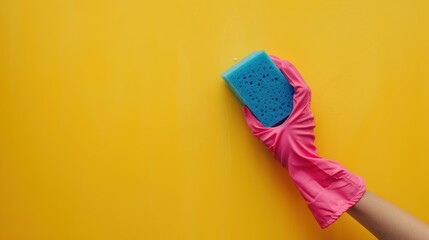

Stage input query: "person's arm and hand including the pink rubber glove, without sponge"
[{"left": 243, "top": 56, "right": 429, "bottom": 236}]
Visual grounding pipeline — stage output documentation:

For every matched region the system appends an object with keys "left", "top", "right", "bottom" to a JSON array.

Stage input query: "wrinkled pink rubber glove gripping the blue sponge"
[{"left": 243, "top": 56, "right": 365, "bottom": 228}]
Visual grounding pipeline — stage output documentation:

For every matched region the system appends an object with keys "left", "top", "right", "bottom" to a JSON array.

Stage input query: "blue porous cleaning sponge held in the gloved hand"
[{"left": 222, "top": 51, "right": 295, "bottom": 127}]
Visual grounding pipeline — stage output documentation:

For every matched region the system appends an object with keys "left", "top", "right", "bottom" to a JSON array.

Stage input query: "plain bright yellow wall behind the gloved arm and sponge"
[{"left": 0, "top": 0, "right": 429, "bottom": 240}]
